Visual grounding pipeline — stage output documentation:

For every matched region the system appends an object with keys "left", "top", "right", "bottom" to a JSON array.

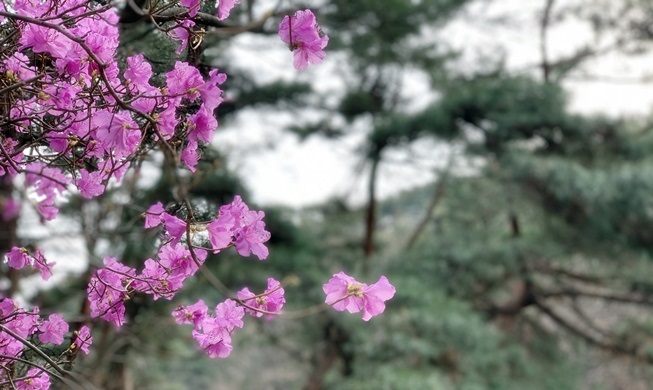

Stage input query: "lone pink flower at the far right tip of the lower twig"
[{"left": 322, "top": 272, "right": 395, "bottom": 321}]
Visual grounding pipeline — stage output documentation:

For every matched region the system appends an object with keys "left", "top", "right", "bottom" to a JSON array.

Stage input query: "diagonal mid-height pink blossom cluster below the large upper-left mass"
[{"left": 87, "top": 196, "right": 270, "bottom": 327}]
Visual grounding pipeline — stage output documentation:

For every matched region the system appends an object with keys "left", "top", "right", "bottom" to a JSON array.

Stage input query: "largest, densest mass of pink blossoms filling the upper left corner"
[{"left": 0, "top": 0, "right": 228, "bottom": 220}]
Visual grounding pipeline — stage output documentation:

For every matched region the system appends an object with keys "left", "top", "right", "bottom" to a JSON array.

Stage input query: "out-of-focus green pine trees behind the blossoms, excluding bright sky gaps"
[{"left": 8, "top": 0, "right": 653, "bottom": 390}]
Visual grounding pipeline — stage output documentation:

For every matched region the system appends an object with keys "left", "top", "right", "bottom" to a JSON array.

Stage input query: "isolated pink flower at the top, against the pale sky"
[{"left": 279, "top": 9, "right": 329, "bottom": 69}]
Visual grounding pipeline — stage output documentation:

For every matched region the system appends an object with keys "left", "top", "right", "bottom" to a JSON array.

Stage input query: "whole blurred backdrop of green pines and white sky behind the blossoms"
[{"left": 2, "top": 0, "right": 653, "bottom": 390}]
